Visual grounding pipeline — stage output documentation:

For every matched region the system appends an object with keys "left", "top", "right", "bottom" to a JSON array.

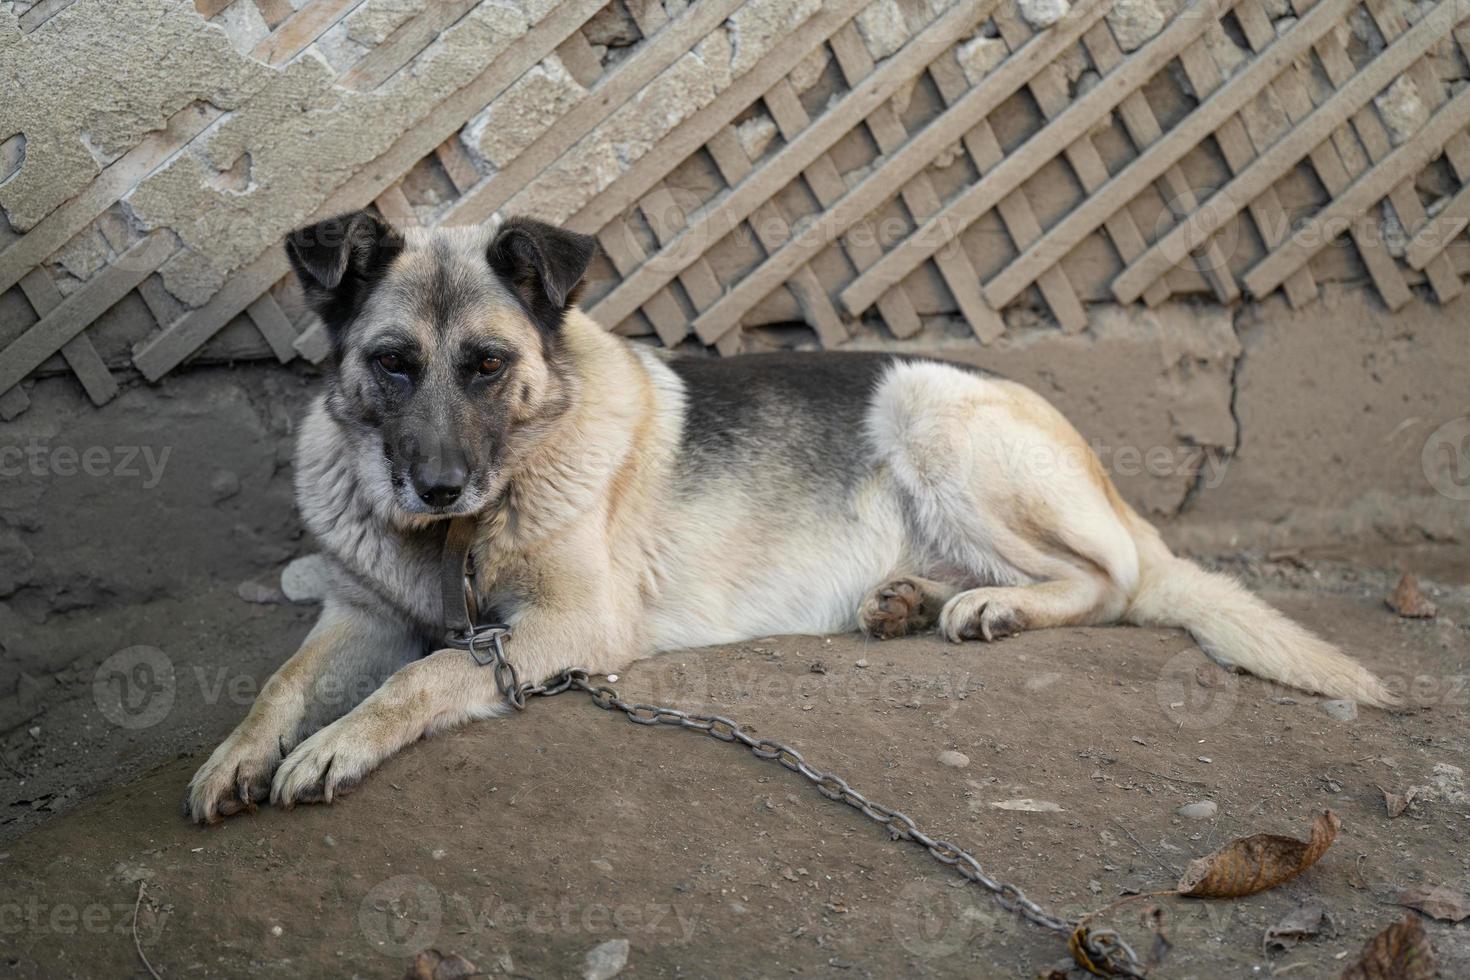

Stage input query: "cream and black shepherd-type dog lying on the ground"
[{"left": 185, "top": 212, "right": 1392, "bottom": 823}]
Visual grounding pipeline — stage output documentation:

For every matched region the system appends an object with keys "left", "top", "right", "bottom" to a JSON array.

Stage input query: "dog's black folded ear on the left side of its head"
[{"left": 285, "top": 212, "right": 403, "bottom": 338}]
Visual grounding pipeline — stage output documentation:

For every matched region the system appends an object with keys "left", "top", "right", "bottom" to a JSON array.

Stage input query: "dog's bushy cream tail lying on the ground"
[{"left": 1123, "top": 514, "right": 1395, "bottom": 707}]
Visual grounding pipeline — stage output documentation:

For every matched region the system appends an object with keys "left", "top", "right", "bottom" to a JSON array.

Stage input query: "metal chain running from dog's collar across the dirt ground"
[{"left": 505, "top": 664, "right": 1145, "bottom": 977}]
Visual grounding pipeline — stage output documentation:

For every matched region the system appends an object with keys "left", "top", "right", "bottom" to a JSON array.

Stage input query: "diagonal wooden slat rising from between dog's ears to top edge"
[{"left": 442, "top": 0, "right": 741, "bottom": 225}]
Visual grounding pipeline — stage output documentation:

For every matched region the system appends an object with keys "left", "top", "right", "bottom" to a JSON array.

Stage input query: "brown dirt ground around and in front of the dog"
[{"left": 0, "top": 550, "right": 1470, "bottom": 980}]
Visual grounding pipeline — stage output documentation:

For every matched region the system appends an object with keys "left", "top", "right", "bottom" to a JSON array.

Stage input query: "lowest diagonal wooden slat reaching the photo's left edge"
[{"left": 0, "top": 232, "right": 176, "bottom": 391}]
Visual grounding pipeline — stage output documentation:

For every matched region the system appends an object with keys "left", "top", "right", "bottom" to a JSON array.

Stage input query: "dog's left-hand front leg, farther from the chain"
[{"left": 184, "top": 599, "right": 423, "bottom": 823}]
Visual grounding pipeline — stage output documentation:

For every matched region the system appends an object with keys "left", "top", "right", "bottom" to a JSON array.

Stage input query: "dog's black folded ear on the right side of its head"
[{"left": 487, "top": 217, "right": 597, "bottom": 331}]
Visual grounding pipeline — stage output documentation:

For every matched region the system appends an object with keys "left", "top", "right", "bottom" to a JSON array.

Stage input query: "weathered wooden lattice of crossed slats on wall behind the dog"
[{"left": 0, "top": 0, "right": 1470, "bottom": 419}]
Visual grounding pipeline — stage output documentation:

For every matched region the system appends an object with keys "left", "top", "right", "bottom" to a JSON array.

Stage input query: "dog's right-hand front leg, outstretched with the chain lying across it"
[{"left": 270, "top": 610, "right": 637, "bottom": 807}]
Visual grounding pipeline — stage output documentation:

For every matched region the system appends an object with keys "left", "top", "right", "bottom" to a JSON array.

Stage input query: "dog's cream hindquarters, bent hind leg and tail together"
[{"left": 867, "top": 363, "right": 1394, "bottom": 705}]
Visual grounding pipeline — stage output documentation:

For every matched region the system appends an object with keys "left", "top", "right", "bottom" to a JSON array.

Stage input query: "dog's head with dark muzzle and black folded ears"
[{"left": 285, "top": 212, "right": 594, "bottom": 517}]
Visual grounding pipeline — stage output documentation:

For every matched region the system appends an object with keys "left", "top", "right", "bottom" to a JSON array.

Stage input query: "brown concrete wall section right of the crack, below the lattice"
[{"left": 1179, "top": 287, "right": 1470, "bottom": 548}]
